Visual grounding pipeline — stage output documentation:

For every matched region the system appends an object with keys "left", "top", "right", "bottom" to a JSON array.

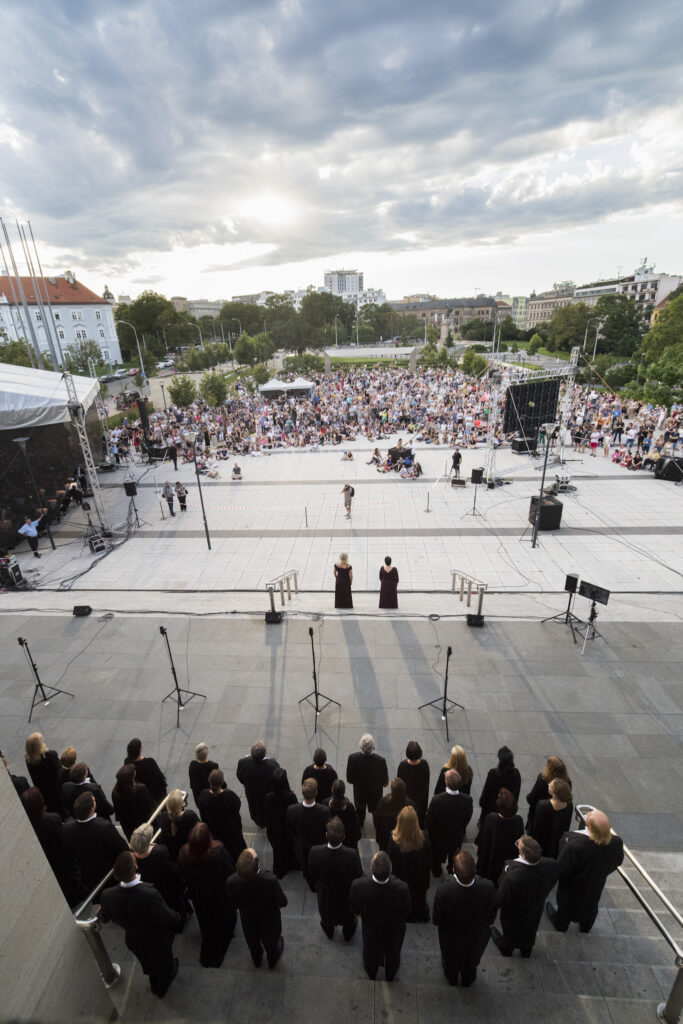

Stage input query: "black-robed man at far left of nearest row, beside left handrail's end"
[{"left": 100, "top": 851, "right": 180, "bottom": 999}]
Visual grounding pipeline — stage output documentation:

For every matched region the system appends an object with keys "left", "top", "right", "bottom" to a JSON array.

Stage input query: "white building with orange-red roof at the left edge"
[{"left": 0, "top": 270, "right": 121, "bottom": 369}]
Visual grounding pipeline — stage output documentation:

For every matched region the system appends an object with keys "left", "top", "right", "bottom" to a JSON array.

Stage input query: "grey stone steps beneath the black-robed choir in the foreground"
[{"left": 102, "top": 825, "right": 683, "bottom": 1024}]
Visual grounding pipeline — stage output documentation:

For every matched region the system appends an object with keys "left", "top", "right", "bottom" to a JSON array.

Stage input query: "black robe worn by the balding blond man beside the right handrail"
[{"left": 557, "top": 831, "right": 624, "bottom": 927}]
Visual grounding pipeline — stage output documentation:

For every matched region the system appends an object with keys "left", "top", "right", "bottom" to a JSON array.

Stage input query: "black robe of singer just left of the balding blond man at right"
[{"left": 496, "top": 857, "right": 558, "bottom": 952}]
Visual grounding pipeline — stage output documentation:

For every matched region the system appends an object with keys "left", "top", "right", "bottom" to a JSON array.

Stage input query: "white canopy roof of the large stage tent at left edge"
[{"left": 0, "top": 362, "right": 99, "bottom": 430}]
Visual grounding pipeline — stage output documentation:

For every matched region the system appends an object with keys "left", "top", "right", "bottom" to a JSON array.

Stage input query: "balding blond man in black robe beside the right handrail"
[{"left": 547, "top": 810, "right": 624, "bottom": 932}]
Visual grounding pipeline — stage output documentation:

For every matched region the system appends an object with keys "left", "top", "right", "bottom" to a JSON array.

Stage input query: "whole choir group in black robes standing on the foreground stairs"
[{"left": 3, "top": 732, "right": 624, "bottom": 996}]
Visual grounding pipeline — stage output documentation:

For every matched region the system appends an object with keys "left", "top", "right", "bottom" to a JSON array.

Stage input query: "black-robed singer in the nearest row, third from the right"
[{"left": 432, "top": 850, "right": 496, "bottom": 988}]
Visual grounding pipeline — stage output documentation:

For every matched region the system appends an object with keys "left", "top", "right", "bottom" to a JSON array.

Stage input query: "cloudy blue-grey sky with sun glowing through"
[{"left": 0, "top": 0, "right": 683, "bottom": 298}]
